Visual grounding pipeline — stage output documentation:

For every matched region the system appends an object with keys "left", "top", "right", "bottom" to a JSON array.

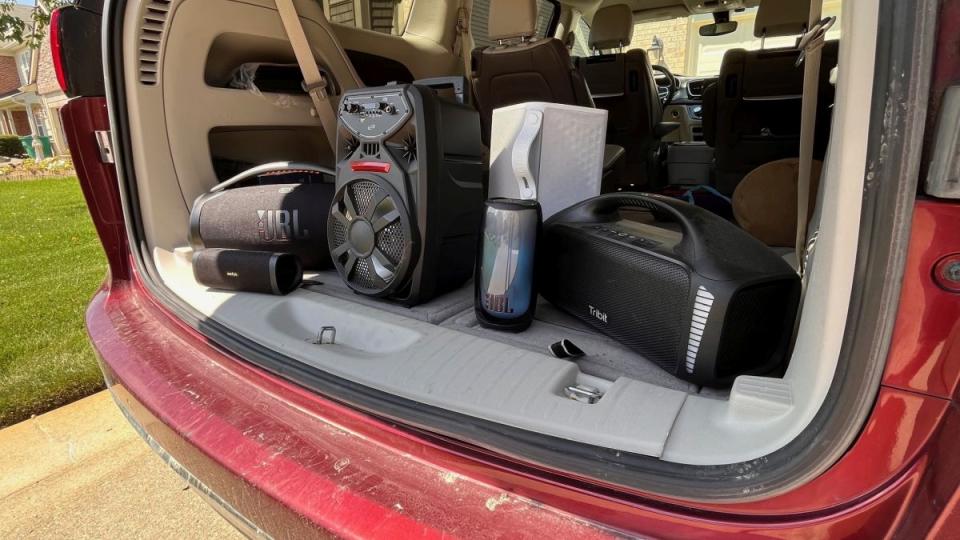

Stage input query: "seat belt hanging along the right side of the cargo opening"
[{"left": 796, "top": 0, "right": 836, "bottom": 276}]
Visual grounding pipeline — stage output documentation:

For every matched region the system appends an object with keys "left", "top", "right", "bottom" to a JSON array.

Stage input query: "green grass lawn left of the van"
[{"left": 0, "top": 178, "right": 106, "bottom": 427}]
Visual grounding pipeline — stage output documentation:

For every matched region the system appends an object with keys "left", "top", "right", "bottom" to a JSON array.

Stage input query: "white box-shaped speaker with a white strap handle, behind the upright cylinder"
[{"left": 489, "top": 101, "right": 607, "bottom": 219}]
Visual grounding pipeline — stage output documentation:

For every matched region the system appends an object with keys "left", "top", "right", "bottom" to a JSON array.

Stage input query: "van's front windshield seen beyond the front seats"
[{"left": 616, "top": 0, "right": 841, "bottom": 77}]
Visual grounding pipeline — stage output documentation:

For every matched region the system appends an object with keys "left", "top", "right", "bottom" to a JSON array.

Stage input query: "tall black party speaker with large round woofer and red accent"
[{"left": 327, "top": 77, "right": 484, "bottom": 305}]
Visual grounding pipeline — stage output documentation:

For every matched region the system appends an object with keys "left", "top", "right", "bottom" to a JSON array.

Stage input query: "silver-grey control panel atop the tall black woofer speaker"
[{"left": 339, "top": 88, "right": 412, "bottom": 139}]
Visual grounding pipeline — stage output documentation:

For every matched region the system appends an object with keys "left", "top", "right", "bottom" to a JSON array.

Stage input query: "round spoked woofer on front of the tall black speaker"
[{"left": 327, "top": 176, "right": 418, "bottom": 296}]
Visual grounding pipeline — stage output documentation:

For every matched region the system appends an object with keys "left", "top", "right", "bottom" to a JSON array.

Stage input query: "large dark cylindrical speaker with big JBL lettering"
[{"left": 190, "top": 184, "right": 334, "bottom": 269}]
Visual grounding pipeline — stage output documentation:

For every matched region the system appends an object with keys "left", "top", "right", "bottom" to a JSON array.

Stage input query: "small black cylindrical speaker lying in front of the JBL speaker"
[{"left": 193, "top": 249, "right": 303, "bottom": 294}]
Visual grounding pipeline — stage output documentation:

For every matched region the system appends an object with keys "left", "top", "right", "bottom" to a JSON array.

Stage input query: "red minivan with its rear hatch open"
[{"left": 51, "top": 0, "right": 960, "bottom": 538}]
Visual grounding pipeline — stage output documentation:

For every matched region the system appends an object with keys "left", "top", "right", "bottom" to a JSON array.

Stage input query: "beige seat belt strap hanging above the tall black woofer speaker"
[{"left": 276, "top": 0, "right": 337, "bottom": 155}]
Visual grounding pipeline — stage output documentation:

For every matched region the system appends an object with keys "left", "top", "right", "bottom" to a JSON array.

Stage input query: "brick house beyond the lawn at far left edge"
[{"left": 0, "top": 5, "right": 68, "bottom": 157}]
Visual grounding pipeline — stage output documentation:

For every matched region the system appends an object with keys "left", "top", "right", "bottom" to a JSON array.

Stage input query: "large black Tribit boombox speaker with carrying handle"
[{"left": 539, "top": 193, "right": 800, "bottom": 386}]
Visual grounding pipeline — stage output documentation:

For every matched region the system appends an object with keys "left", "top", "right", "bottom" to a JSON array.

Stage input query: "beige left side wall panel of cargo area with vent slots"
[{"left": 124, "top": 0, "right": 359, "bottom": 249}]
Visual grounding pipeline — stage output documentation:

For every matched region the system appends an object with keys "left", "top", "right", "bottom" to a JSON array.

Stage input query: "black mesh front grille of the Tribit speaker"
[{"left": 541, "top": 226, "right": 690, "bottom": 373}]
